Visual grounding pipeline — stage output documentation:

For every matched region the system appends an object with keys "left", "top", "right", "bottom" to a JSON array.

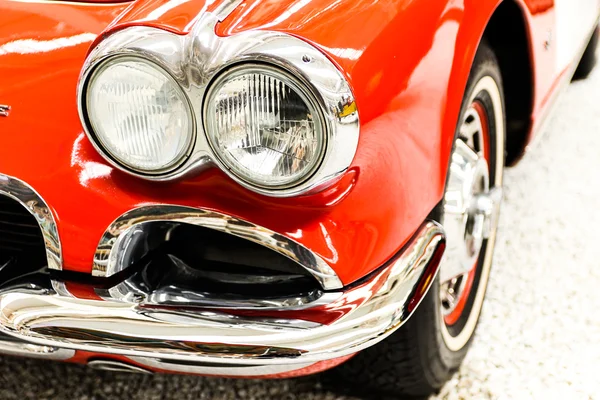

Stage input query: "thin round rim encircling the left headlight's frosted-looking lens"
[{"left": 79, "top": 52, "right": 198, "bottom": 177}]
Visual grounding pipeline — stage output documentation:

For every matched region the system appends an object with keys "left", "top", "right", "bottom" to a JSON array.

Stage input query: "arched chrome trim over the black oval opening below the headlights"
[{"left": 92, "top": 205, "right": 343, "bottom": 290}]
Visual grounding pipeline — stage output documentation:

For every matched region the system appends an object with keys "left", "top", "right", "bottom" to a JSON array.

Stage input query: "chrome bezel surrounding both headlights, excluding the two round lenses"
[{"left": 78, "top": 3, "right": 360, "bottom": 197}]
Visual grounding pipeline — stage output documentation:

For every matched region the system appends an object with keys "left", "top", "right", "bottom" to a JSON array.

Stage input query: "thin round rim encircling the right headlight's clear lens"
[{"left": 202, "top": 62, "right": 330, "bottom": 192}]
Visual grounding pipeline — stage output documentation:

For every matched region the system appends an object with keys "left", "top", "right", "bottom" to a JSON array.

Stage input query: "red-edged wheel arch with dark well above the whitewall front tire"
[{"left": 442, "top": 0, "right": 535, "bottom": 176}]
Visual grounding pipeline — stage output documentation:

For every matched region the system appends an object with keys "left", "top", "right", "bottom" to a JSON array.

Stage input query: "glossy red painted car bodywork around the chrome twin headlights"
[{"left": 0, "top": 0, "right": 592, "bottom": 284}]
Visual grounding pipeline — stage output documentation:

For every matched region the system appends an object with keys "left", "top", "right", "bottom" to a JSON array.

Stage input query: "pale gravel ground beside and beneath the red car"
[{"left": 0, "top": 48, "right": 600, "bottom": 400}]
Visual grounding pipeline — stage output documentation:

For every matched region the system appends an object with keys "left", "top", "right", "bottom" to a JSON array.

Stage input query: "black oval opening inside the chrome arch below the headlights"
[{"left": 116, "top": 222, "right": 322, "bottom": 300}]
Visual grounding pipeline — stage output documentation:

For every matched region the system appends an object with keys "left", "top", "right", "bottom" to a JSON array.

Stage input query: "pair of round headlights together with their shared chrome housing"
[{"left": 77, "top": 25, "right": 360, "bottom": 197}]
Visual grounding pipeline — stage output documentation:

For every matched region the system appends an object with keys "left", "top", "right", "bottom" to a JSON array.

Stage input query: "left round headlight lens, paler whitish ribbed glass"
[{"left": 86, "top": 57, "right": 193, "bottom": 173}]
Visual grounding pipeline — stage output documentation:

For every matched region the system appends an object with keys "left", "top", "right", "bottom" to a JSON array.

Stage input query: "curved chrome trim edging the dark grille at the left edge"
[{"left": 0, "top": 174, "right": 62, "bottom": 270}]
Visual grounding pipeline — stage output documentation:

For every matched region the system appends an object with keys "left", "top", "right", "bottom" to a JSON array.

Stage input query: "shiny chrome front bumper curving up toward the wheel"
[{"left": 0, "top": 222, "right": 445, "bottom": 365}]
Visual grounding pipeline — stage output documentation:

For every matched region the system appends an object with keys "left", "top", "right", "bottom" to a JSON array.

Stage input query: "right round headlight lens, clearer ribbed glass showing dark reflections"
[{"left": 204, "top": 66, "right": 326, "bottom": 189}]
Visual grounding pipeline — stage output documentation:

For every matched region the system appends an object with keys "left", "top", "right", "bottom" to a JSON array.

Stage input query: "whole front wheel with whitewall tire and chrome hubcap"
[{"left": 332, "top": 42, "right": 505, "bottom": 396}]
